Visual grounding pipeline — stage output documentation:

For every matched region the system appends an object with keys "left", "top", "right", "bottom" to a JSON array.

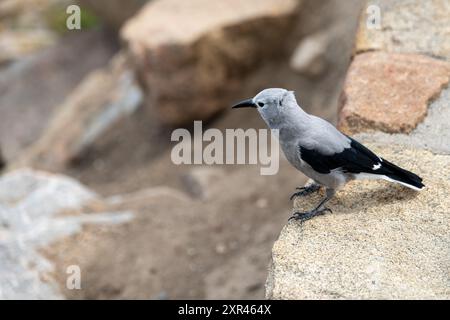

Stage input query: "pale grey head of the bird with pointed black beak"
[{"left": 233, "top": 88, "right": 299, "bottom": 126}]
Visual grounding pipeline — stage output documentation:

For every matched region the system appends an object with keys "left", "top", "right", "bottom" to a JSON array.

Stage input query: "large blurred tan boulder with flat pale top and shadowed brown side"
[{"left": 121, "top": 0, "right": 300, "bottom": 125}]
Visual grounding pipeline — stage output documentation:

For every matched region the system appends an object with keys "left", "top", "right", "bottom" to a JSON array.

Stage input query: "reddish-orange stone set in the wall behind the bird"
[{"left": 339, "top": 52, "right": 450, "bottom": 133}]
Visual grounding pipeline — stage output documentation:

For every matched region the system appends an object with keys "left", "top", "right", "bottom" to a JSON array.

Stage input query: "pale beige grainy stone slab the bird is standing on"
[{"left": 266, "top": 145, "right": 450, "bottom": 299}]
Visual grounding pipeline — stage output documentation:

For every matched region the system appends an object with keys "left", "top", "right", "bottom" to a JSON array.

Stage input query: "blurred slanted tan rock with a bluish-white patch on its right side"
[{"left": 16, "top": 54, "right": 143, "bottom": 170}]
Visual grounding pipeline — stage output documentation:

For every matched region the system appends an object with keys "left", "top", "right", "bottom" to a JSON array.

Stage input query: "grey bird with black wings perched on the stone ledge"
[{"left": 232, "top": 88, "right": 425, "bottom": 222}]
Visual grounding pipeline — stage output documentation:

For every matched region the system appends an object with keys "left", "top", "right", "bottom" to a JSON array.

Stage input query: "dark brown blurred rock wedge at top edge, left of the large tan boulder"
[{"left": 77, "top": 0, "right": 151, "bottom": 30}]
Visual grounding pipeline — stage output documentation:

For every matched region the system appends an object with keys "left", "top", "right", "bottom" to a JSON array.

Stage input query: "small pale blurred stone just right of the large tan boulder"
[{"left": 290, "top": 31, "right": 330, "bottom": 77}]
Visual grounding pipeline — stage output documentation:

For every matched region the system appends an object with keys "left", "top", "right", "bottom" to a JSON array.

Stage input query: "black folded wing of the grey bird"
[{"left": 299, "top": 137, "right": 381, "bottom": 174}]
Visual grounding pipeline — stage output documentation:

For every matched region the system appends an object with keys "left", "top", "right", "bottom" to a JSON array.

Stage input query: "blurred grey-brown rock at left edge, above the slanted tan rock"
[{"left": 0, "top": 31, "right": 117, "bottom": 162}]
